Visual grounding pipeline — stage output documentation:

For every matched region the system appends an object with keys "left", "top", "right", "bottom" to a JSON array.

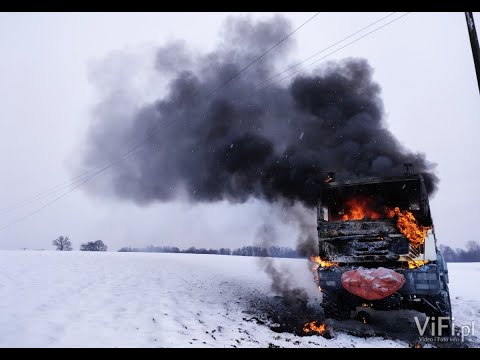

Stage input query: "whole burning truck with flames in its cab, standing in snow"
[{"left": 311, "top": 164, "right": 452, "bottom": 331}]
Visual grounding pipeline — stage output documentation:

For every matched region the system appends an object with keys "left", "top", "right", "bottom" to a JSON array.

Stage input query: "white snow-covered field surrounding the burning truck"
[{"left": 0, "top": 251, "right": 480, "bottom": 347}]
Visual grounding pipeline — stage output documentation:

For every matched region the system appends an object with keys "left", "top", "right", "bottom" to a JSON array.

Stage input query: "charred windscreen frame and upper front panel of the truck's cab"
[{"left": 317, "top": 173, "right": 434, "bottom": 264}]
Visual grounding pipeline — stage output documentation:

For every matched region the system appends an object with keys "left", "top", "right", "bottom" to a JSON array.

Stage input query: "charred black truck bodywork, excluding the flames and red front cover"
[{"left": 317, "top": 174, "right": 451, "bottom": 316}]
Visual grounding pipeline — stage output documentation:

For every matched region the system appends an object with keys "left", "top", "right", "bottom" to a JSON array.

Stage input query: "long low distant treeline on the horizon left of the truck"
[{"left": 118, "top": 245, "right": 301, "bottom": 258}]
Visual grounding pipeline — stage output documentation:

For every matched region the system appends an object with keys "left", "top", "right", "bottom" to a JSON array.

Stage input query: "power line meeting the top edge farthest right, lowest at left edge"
[{"left": 0, "top": 12, "right": 410, "bottom": 231}]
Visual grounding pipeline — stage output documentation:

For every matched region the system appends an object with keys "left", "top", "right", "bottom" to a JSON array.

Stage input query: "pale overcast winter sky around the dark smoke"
[{"left": 0, "top": 13, "right": 480, "bottom": 250}]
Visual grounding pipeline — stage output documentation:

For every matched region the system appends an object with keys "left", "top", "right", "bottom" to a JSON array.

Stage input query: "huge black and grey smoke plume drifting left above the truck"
[{"left": 84, "top": 16, "right": 438, "bottom": 207}]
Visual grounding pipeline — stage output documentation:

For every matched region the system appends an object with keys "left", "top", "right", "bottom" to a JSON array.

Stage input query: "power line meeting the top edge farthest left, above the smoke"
[{"left": 0, "top": 12, "right": 320, "bottom": 219}]
